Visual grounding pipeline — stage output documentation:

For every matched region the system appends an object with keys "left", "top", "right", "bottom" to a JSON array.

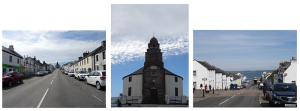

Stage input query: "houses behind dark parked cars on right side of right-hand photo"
[{"left": 262, "top": 57, "right": 297, "bottom": 85}]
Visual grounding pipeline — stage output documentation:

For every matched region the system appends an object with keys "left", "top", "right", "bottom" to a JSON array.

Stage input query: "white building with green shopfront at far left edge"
[{"left": 2, "top": 45, "right": 23, "bottom": 72}]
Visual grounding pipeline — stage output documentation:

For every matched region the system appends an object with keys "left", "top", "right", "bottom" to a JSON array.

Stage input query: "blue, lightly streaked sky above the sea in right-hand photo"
[{"left": 192, "top": 29, "right": 297, "bottom": 71}]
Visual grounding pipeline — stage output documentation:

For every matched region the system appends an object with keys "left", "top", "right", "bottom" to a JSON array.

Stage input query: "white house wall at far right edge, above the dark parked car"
[{"left": 283, "top": 60, "right": 298, "bottom": 85}]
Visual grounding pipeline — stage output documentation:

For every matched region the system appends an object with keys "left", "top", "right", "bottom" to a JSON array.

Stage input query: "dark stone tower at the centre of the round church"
[{"left": 142, "top": 37, "right": 165, "bottom": 104}]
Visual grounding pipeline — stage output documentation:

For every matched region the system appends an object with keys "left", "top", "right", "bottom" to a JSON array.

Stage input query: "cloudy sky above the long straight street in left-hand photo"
[{"left": 2, "top": 30, "right": 106, "bottom": 66}]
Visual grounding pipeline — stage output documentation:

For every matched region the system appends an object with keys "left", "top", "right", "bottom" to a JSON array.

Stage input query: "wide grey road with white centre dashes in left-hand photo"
[{"left": 2, "top": 69, "right": 106, "bottom": 109}]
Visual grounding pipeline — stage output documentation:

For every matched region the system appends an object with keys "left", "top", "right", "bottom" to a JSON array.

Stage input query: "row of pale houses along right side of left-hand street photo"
[{"left": 62, "top": 40, "right": 106, "bottom": 72}]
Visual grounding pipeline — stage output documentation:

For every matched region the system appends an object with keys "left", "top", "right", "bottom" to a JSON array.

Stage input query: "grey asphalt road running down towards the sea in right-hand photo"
[{"left": 192, "top": 79, "right": 261, "bottom": 108}]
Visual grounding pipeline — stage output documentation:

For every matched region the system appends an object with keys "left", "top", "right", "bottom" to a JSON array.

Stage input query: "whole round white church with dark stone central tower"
[{"left": 122, "top": 37, "right": 183, "bottom": 104}]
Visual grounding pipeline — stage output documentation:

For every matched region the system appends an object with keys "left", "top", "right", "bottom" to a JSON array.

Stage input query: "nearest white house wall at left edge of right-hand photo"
[{"left": 192, "top": 60, "right": 208, "bottom": 89}]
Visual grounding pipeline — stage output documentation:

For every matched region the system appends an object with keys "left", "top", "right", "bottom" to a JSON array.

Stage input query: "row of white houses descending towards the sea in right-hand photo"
[{"left": 192, "top": 60, "right": 246, "bottom": 89}]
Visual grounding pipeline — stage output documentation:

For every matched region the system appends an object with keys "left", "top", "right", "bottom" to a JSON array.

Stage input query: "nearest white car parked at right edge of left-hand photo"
[{"left": 84, "top": 70, "right": 106, "bottom": 90}]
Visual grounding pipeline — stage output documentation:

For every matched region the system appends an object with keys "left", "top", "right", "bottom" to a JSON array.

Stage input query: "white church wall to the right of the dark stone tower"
[{"left": 165, "top": 75, "right": 183, "bottom": 96}]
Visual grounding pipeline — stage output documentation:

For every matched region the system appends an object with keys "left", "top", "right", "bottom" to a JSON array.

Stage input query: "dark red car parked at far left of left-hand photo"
[{"left": 2, "top": 71, "right": 23, "bottom": 87}]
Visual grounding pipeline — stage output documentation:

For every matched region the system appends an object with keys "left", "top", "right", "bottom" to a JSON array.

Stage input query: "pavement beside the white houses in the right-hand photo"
[{"left": 192, "top": 89, "right": 230, "bottom": 102}]
